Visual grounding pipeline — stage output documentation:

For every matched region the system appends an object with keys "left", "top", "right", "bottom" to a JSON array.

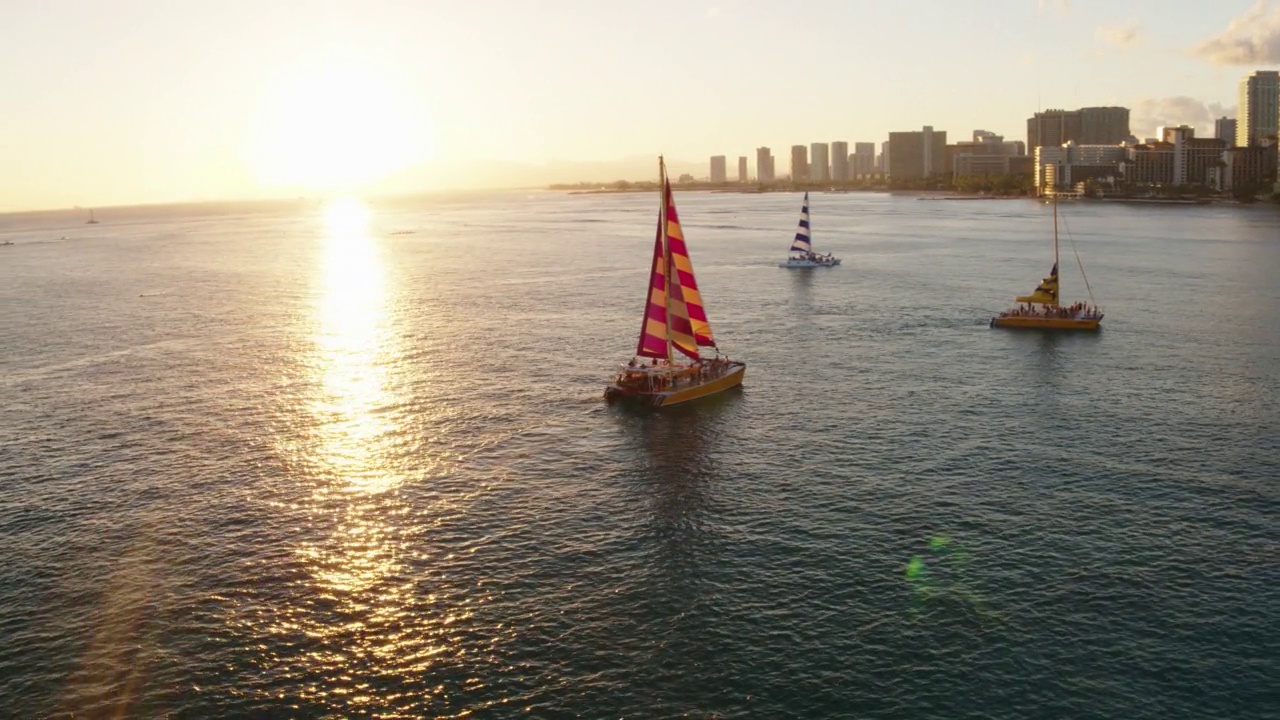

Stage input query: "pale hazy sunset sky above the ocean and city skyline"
[{"left": 0, "top": 0, "right": 1280, "bottom": 211}]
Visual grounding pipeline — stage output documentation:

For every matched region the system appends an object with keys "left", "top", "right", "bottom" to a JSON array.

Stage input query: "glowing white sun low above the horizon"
[{"left": 251, "top": 63, "right": 434, "bottom": 191}]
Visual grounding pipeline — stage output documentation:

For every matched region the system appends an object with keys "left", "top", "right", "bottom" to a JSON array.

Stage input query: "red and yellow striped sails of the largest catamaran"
[{"left": 636, "top": 177, "right": 714, "bottom": 360}]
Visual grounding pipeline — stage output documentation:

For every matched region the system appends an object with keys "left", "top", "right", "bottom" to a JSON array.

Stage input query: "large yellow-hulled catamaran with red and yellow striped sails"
[{"left": 604, "top": 158, "right": 746, "bottom": 407}]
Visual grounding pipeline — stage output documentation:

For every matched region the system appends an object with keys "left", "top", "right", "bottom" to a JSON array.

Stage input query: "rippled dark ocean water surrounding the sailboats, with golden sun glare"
[{"left": 0, "top": 192, "right": 1280, "bottom": 720}]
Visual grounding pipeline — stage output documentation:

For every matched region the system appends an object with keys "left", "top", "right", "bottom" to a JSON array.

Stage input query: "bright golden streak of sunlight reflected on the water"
[{"left": 270, "top": 200, "right": 454, "bottom": 708}]
